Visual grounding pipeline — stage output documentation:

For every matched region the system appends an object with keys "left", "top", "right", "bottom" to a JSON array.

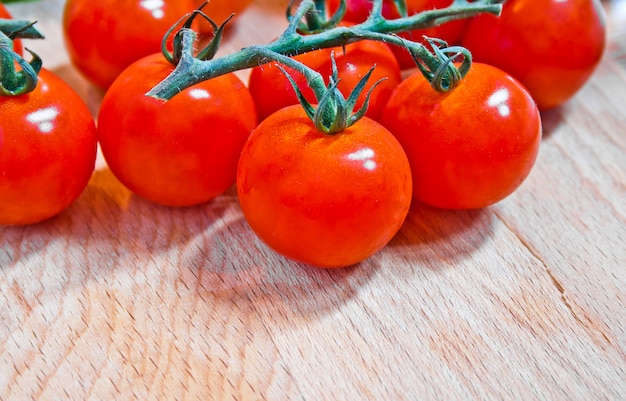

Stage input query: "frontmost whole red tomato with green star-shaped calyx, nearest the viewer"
[{"left": 237, "top": 105, "right": 411, "bottom": 268}]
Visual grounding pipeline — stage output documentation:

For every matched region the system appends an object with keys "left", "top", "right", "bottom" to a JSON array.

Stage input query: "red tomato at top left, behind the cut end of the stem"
[{"left": 63, "top": 0, "right": 194, "bottom": 89}]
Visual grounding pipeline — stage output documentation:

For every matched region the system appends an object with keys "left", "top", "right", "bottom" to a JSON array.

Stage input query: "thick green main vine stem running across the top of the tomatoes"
[{"left": 146, "top": 0, "right": 505, "bottom": 100}]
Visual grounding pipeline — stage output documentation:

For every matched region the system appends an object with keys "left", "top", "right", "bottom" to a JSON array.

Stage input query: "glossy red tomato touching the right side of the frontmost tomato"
[{"left": 382, "top": 63, "right": 541, "bottom": 209}]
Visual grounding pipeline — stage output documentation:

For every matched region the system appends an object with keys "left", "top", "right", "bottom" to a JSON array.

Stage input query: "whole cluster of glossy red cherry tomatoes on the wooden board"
[{"left": 0, "top": 0, "right": 605, "bottom": 267}]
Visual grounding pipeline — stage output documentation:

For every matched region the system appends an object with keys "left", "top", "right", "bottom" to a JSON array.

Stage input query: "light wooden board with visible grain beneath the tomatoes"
[{"left": 0, "top": 0, "right": 626, "bottom": 401}]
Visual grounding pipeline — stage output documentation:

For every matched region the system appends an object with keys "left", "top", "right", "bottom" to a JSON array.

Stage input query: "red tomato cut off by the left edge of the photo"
[{"left": 0, "top": 69, "right": 97, "bottom": 225}]
